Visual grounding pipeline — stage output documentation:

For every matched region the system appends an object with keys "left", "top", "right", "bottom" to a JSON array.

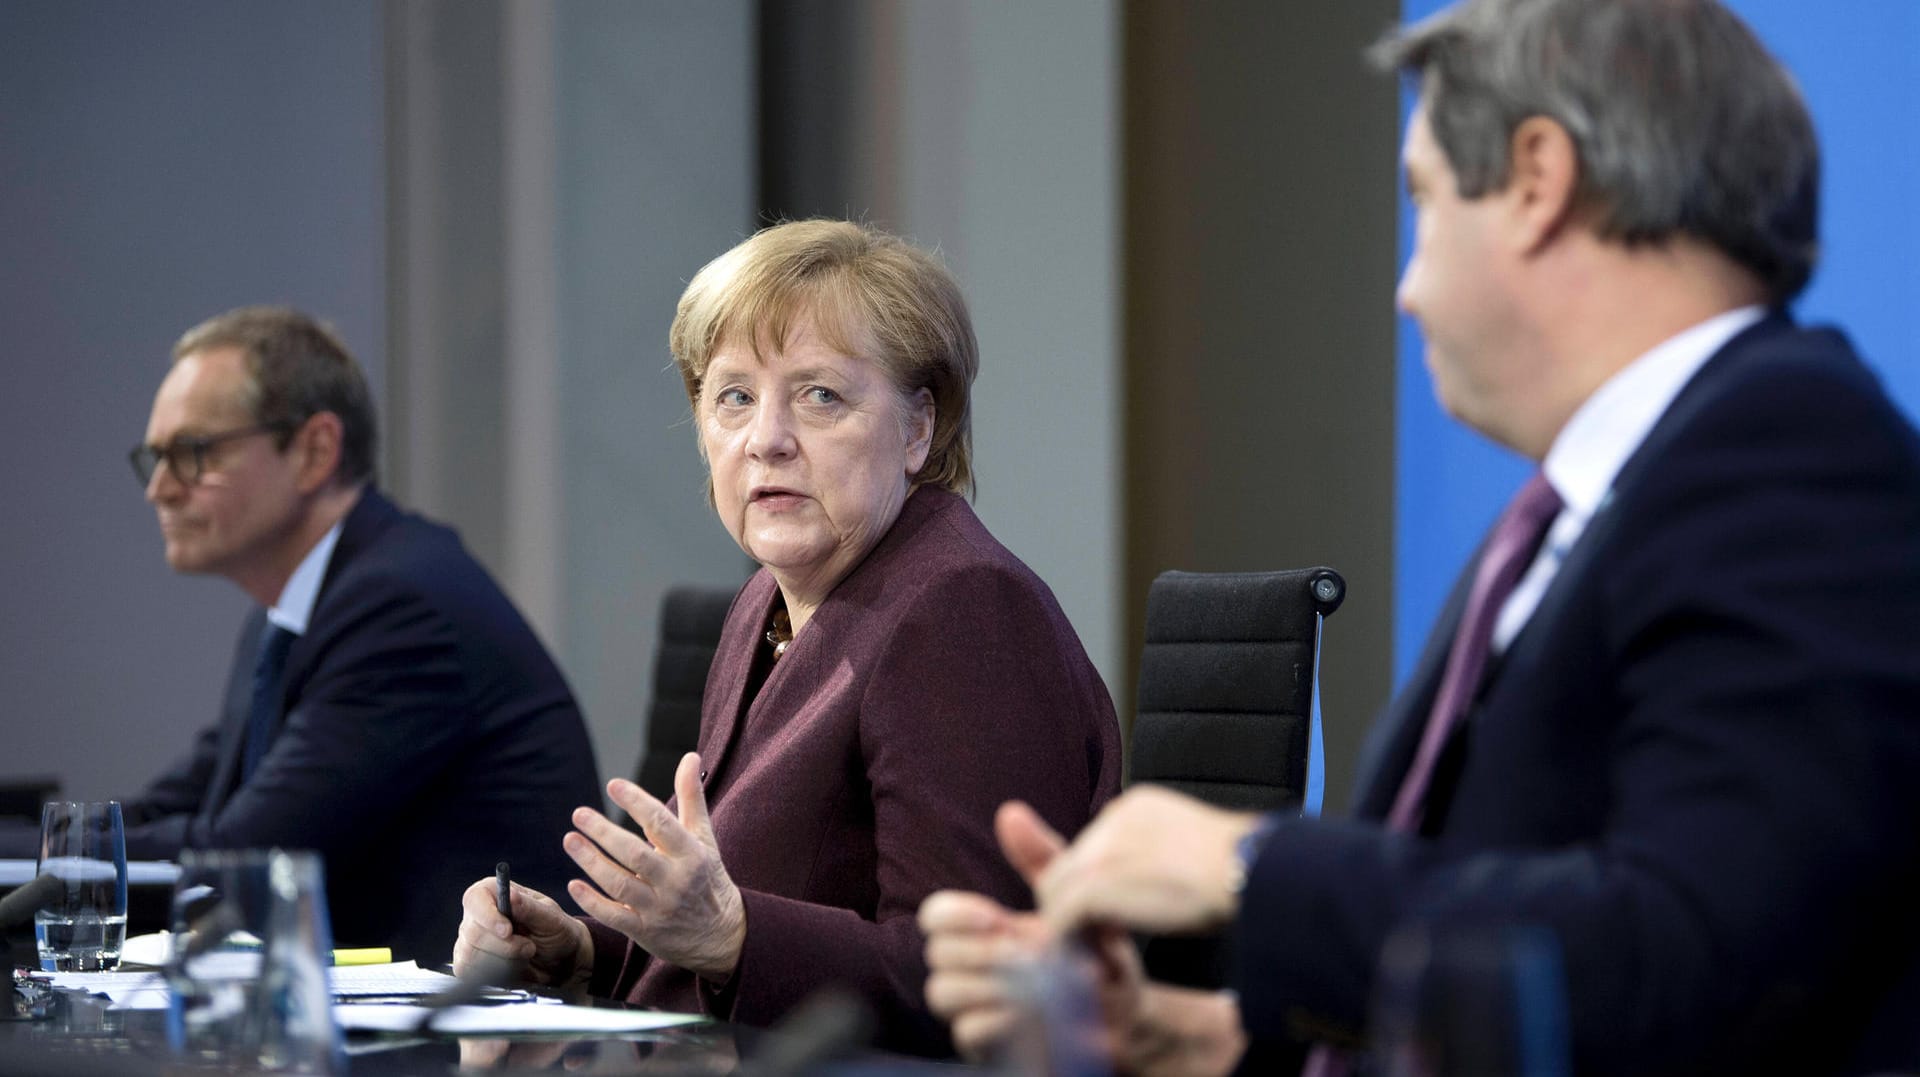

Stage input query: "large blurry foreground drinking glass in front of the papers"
[{"left": 167, "top": 849, "right": 346, "bottom": 1073}]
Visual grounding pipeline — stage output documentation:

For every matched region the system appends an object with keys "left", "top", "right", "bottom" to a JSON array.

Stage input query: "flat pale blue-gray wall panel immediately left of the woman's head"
[{"left": 553, "top": 0, "right": 755, "bottom": 776}]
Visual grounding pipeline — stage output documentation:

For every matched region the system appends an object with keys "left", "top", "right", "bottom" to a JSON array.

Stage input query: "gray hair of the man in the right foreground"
[{"left": 1371, "top": 0, "right": 1820, "bottom": 303}]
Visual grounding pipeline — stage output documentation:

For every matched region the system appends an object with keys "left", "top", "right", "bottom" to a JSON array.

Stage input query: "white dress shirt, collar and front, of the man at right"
[{"left": 1494, "top": 307, "right": 1766, "bottom": 655}]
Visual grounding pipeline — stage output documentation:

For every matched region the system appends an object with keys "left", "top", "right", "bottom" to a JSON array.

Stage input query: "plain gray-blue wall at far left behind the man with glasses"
[{"left": 0, "top": 0, "right": 386, "bottom": 797}]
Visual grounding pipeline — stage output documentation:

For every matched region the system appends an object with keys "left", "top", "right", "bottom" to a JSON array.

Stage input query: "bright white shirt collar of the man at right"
[{"left": 1540, "top": 305, "right": 1766, "bottom": 522}]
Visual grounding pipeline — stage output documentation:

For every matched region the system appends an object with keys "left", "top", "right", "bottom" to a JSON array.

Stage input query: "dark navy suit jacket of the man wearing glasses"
[{"left": 125, "top": 488, "right": 601, "bottom": 960}]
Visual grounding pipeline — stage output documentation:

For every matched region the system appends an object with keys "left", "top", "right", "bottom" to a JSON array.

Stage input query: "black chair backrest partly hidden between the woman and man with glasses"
[{"left": 634, "top": 586, "right": 735, "bottom": 801}]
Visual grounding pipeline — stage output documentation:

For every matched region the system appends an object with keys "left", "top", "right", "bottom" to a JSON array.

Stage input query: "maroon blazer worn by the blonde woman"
[{"left": 589, "top": 488, "right": 1119, "bottom": 1052}]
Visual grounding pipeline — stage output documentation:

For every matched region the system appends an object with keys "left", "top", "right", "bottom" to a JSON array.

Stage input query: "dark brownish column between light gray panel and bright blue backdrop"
[{"left": 1125, "top": 0, "right": 1398, "bottom": 808}]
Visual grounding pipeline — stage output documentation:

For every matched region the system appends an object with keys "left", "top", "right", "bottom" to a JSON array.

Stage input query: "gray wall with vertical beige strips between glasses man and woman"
[{"left": 388, "top": 0, "right": 755, "bottom": 790}]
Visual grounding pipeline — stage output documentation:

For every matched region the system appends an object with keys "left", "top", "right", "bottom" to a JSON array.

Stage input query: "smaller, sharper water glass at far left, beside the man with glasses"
[{"left": 33, "top": 801, "right": 127, "bottom": 971}]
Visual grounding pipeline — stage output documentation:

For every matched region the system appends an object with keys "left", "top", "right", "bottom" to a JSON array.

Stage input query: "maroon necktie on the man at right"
[{"left": 1300, "top": 472, "right": 1561, "bottom": 1077}]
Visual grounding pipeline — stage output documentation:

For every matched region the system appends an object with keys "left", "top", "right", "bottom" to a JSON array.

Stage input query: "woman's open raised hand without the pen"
[{"left": 563, "top": 753, "right": 747, "bottom": 981}]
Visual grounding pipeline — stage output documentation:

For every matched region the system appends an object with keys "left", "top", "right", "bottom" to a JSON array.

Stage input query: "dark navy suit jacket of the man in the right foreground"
[{"left": 1236, "top": 317, "right": 1920, "bottom": 1073}]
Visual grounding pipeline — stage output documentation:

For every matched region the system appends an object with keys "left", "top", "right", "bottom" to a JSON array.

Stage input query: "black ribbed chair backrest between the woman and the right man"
[{"left": 1129, "top": 568, "right": 1346, "bottom": 810}]
